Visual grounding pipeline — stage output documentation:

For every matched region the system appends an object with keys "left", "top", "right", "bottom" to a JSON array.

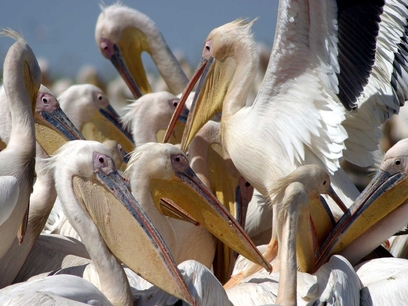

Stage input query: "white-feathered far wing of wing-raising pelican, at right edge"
[{"left": 343, "top": 1, "right": 408, "bottom": 167}]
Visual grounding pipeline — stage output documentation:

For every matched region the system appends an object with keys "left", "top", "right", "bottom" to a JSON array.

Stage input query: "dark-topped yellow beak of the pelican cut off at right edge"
[{"left": 317, "top": 170, "right": 408, "bottom": 266}]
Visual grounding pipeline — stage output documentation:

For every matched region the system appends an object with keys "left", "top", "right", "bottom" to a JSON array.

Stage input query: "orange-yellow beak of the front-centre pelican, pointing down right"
[{"left": 150, "top": 154, "right": 272, "bottom": 271}]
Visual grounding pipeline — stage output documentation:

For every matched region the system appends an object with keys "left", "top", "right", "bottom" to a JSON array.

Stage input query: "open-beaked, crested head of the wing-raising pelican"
[{"left": 164, "top": 20, "right": 259, "bottom": 152}]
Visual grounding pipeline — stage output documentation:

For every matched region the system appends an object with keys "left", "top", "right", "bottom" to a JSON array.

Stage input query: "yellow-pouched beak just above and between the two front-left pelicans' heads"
[{"left": 81, "top": 105, "right": 135, "bottom": 152}]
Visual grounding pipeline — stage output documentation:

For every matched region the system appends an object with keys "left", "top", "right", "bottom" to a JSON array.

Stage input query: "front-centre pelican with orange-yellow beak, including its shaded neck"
[{"left": 125, "top": 143, "right": 270, "bottom": 270}]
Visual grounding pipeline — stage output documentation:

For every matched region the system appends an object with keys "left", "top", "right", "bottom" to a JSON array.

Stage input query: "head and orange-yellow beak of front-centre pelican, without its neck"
[{"left": 126, "top": 143, "right": 271, "bottom": 271}]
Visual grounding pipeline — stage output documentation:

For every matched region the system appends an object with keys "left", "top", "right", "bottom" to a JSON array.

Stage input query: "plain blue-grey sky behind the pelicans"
[{"left": 0, "top": 0, "right": 278, "bottom": 80}]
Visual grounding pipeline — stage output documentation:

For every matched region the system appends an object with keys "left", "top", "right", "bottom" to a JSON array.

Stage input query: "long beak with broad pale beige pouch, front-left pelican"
[{"left": 73, "top": 152, "right": 195, "bottom": 305}]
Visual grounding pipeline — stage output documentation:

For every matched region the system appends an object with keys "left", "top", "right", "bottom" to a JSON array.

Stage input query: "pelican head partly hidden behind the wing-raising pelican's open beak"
[{"left": 122, "top": 91, "right": 188, "bottom": 145}]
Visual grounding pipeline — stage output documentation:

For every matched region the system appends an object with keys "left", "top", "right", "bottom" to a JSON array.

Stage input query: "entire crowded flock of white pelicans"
[{"left": 0, "top": 0, "right": 408, "bottom": 306}]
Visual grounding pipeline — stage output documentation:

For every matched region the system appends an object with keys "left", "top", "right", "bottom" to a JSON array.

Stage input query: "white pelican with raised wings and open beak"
[{"left": 165, "top": 0, "right": 407, "bottom": 218}]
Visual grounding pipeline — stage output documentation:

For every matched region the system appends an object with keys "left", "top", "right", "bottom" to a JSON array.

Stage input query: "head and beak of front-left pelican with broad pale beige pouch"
[{"left": 44, "top": 140, "right": 194, "bottom": 304}]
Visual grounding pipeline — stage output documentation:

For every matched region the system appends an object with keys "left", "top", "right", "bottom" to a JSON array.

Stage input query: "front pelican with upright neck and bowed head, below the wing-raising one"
[{"left": 224, "top": 165, "right": 360, "bottom": 305}]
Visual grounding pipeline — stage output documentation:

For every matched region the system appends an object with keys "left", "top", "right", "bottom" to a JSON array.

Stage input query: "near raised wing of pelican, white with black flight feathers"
[{"left": 254, "top": 0, "right": 382, "bottom": 173}]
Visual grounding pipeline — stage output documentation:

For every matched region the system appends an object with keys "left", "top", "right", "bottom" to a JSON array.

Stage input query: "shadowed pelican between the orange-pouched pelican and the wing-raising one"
[{"left": 188, "top": 120, "right": 253, "bottom": 283}]
